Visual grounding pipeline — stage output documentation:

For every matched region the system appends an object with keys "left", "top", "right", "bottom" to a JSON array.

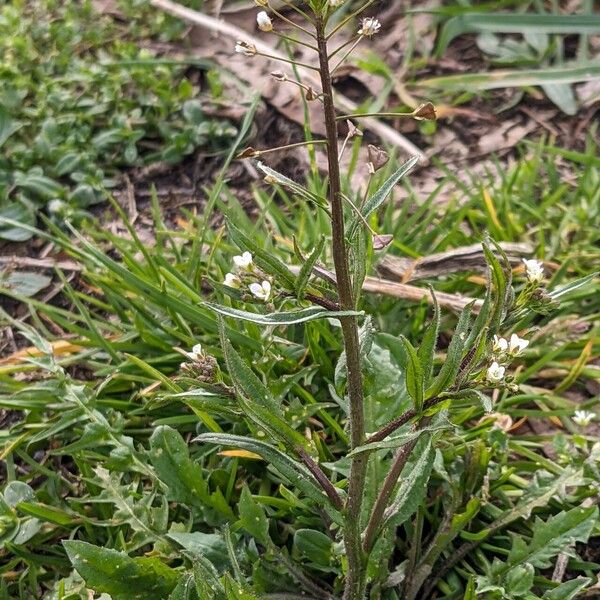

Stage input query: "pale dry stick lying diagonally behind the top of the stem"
[{"left": 150, "top": 0, "right": 428, "bottom": 164}]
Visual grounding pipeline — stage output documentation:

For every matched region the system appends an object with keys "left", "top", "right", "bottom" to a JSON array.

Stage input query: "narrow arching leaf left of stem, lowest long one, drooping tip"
[{"left": 194, "top": 433, "right": 342, "bottom": 524}]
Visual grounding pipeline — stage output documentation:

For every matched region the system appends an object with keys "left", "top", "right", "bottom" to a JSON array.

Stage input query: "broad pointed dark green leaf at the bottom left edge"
[{"left": 63, "top": 540, "right": 177, "bottom": 600}]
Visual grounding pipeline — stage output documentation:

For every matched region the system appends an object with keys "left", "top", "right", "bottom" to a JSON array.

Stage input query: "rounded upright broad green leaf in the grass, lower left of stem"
[{"left": 149, "top": 425, "right": 208, "bottom": 507}]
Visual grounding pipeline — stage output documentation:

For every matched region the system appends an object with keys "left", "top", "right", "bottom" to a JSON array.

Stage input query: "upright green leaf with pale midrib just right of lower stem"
[{"left": 383, "top": 433, "right": 435, "bottom": 527}]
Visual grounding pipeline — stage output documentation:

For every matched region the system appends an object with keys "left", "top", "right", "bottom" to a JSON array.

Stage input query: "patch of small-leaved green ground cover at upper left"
[{"left": 0, "top": 0, "right": 235, "bottom": 241}]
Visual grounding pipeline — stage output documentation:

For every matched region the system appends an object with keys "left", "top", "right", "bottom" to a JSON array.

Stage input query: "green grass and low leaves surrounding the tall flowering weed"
[{"left": 0, "top": 130, "right": 600, "bottom": 599}]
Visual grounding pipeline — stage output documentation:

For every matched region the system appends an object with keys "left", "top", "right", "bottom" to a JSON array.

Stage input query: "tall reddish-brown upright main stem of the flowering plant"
[{"left": 316, "top": 15, "right": 368, "bottom": 600}]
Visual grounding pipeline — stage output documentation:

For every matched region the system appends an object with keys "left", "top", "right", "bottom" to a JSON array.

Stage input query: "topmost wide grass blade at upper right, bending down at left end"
[{"left": 436, "top": 12, "right": 600, "bottom": 57}]
